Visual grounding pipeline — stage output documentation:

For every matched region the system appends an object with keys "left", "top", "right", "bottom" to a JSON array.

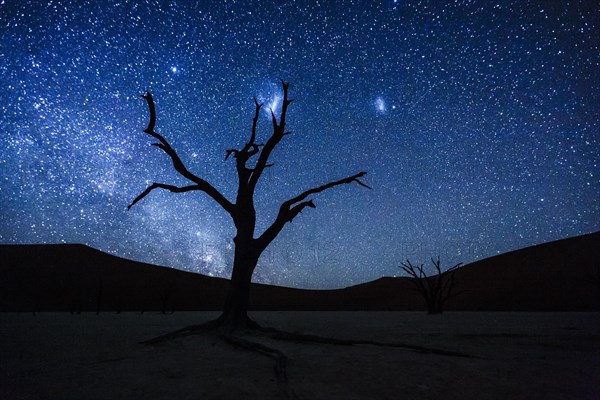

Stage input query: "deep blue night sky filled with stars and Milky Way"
[{"left": 0, "top": 0, "right": 600, "bottom": 288}]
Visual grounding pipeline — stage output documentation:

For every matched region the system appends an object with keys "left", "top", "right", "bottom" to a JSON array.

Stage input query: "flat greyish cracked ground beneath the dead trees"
[{"left": 0, "top": 312, "right": 600, "bottom": 400}]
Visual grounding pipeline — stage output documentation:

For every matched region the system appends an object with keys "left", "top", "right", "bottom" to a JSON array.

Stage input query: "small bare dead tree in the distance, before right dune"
[{"left": 401, "top": 257, "right": 462, "bottom": 314}]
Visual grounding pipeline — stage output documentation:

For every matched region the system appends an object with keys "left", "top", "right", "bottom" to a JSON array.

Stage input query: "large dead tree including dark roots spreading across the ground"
[{"left": 128, "top": 89, "right": 482, "bottom": 399}]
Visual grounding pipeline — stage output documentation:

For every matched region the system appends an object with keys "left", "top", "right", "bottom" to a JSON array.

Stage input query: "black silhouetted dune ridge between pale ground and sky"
[{"left": 0, "top": 232, "right": 600, "bottom": 312}]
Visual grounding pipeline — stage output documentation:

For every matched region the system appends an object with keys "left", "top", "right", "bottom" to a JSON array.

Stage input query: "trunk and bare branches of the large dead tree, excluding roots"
[{"left": 128, "top": 80, "right": 370, "bottom": 330}]
